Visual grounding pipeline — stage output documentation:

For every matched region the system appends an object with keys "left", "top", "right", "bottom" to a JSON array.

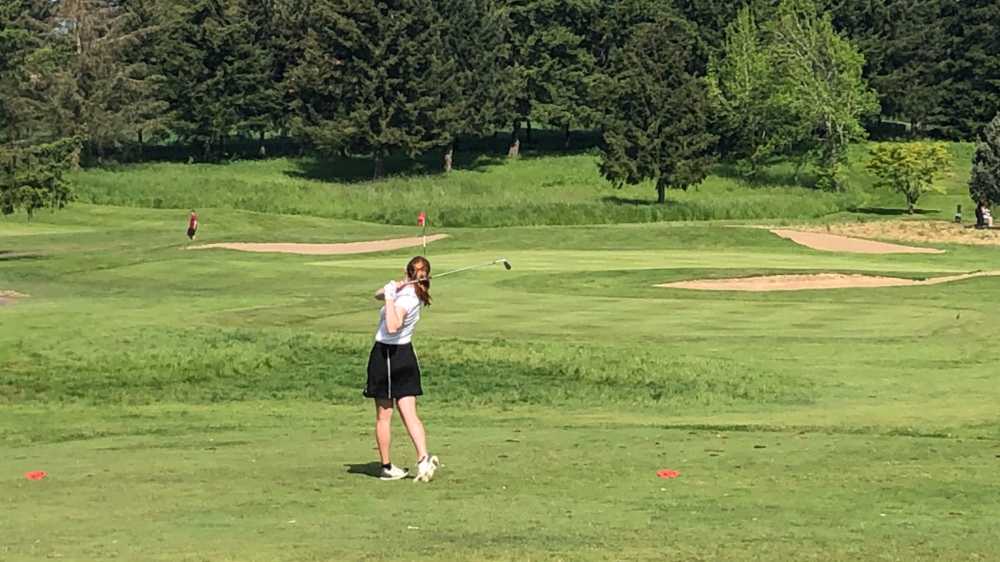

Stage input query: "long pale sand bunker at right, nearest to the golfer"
[{"left": 657, "top": 271, "right": 1000, "bottom": 291}]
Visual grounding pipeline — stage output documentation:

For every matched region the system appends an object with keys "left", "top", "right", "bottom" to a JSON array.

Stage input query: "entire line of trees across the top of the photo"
[{"left": 0, "top": 0, "right": 1000, "bottom": 212}]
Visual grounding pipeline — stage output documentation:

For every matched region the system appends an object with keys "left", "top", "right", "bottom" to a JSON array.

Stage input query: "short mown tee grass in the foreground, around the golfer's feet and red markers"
[{"left": 0, "top": 402, "right": 998, "bottom": 561}]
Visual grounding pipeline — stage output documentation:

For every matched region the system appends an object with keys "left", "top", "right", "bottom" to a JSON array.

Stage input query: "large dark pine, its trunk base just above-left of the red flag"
[{"left": 289, "top": 0, "right": 454, "bottom": 179}]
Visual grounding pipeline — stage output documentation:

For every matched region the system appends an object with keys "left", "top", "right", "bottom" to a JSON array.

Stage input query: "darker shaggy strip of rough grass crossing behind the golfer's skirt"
[{"left": 0, "top": 328, "right": 811, "bottom": 406}]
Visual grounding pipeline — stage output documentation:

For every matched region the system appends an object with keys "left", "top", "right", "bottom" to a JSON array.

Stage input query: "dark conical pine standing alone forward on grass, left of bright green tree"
[{"left": 600, "top": 15, "right": 716, "bottom": 203}]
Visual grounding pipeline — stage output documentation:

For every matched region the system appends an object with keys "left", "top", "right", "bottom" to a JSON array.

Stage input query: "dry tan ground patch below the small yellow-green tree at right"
[{"left": 798, "top": 220, "right": 1000, "bottom": 246}]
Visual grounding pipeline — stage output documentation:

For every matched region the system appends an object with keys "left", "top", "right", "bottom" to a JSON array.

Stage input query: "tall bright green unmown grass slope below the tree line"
[{"left": 74, "top": 154, "right": 865, "bottom": 227}]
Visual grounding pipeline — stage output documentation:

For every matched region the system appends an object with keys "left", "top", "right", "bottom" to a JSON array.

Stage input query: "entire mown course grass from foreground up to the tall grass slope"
[{"left": 0, "top": 204, "right": 1000, "bottom": 562}]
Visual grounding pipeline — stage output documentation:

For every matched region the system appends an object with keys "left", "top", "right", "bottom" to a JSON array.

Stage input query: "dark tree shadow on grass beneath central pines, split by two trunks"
[{"left": 286, "top": 152, "right": 503, "bottom": 183}]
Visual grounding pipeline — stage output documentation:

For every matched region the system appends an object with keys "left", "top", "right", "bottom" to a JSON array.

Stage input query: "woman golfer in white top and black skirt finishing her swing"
[{"left": 364, "top": 256, "right": 440, "bottom": 482}]
